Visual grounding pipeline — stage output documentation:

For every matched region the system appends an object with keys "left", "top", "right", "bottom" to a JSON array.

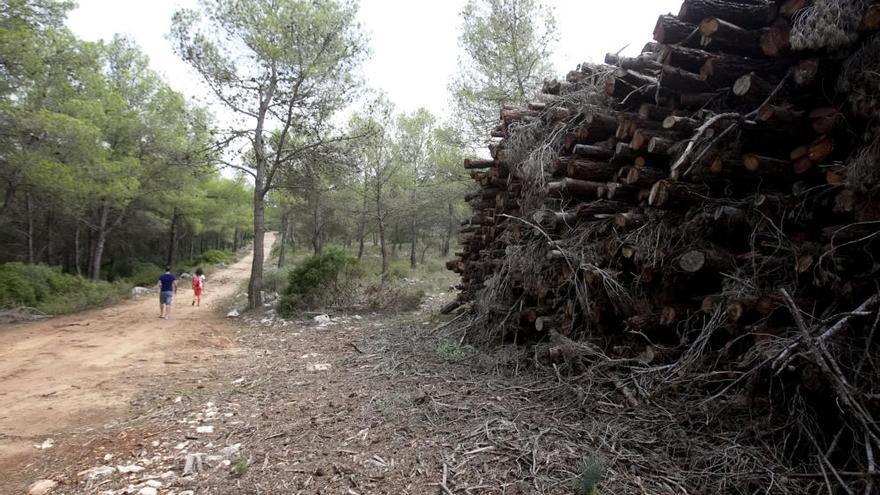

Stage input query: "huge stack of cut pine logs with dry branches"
[{"left": 449, "top": 0, "right": 880, "bottom": 492}]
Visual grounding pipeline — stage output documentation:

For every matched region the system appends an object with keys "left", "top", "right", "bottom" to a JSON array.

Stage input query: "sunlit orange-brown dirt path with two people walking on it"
[{"left": 0, "top": 235, "right": 273, "bottom": 493}]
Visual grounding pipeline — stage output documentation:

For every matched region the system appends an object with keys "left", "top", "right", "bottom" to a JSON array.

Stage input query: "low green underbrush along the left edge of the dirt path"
[{"left": 0, "top": 262, "right": 131, "bottom": 314}]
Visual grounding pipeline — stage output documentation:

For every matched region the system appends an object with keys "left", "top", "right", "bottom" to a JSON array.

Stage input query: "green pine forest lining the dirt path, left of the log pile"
[{"left": 0, "top": 0, "right": 484, "bottom": 309}]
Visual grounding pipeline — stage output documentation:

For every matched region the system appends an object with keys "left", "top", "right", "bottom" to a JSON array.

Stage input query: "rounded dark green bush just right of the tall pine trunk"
[{"left": 278, "top": 249, "right": 364, "bottom": 316}]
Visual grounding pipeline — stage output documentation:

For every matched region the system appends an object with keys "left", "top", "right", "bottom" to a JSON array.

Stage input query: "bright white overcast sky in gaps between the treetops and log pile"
[{"left": 68, "top": 0, "right": 681, "bottom": 122}]
